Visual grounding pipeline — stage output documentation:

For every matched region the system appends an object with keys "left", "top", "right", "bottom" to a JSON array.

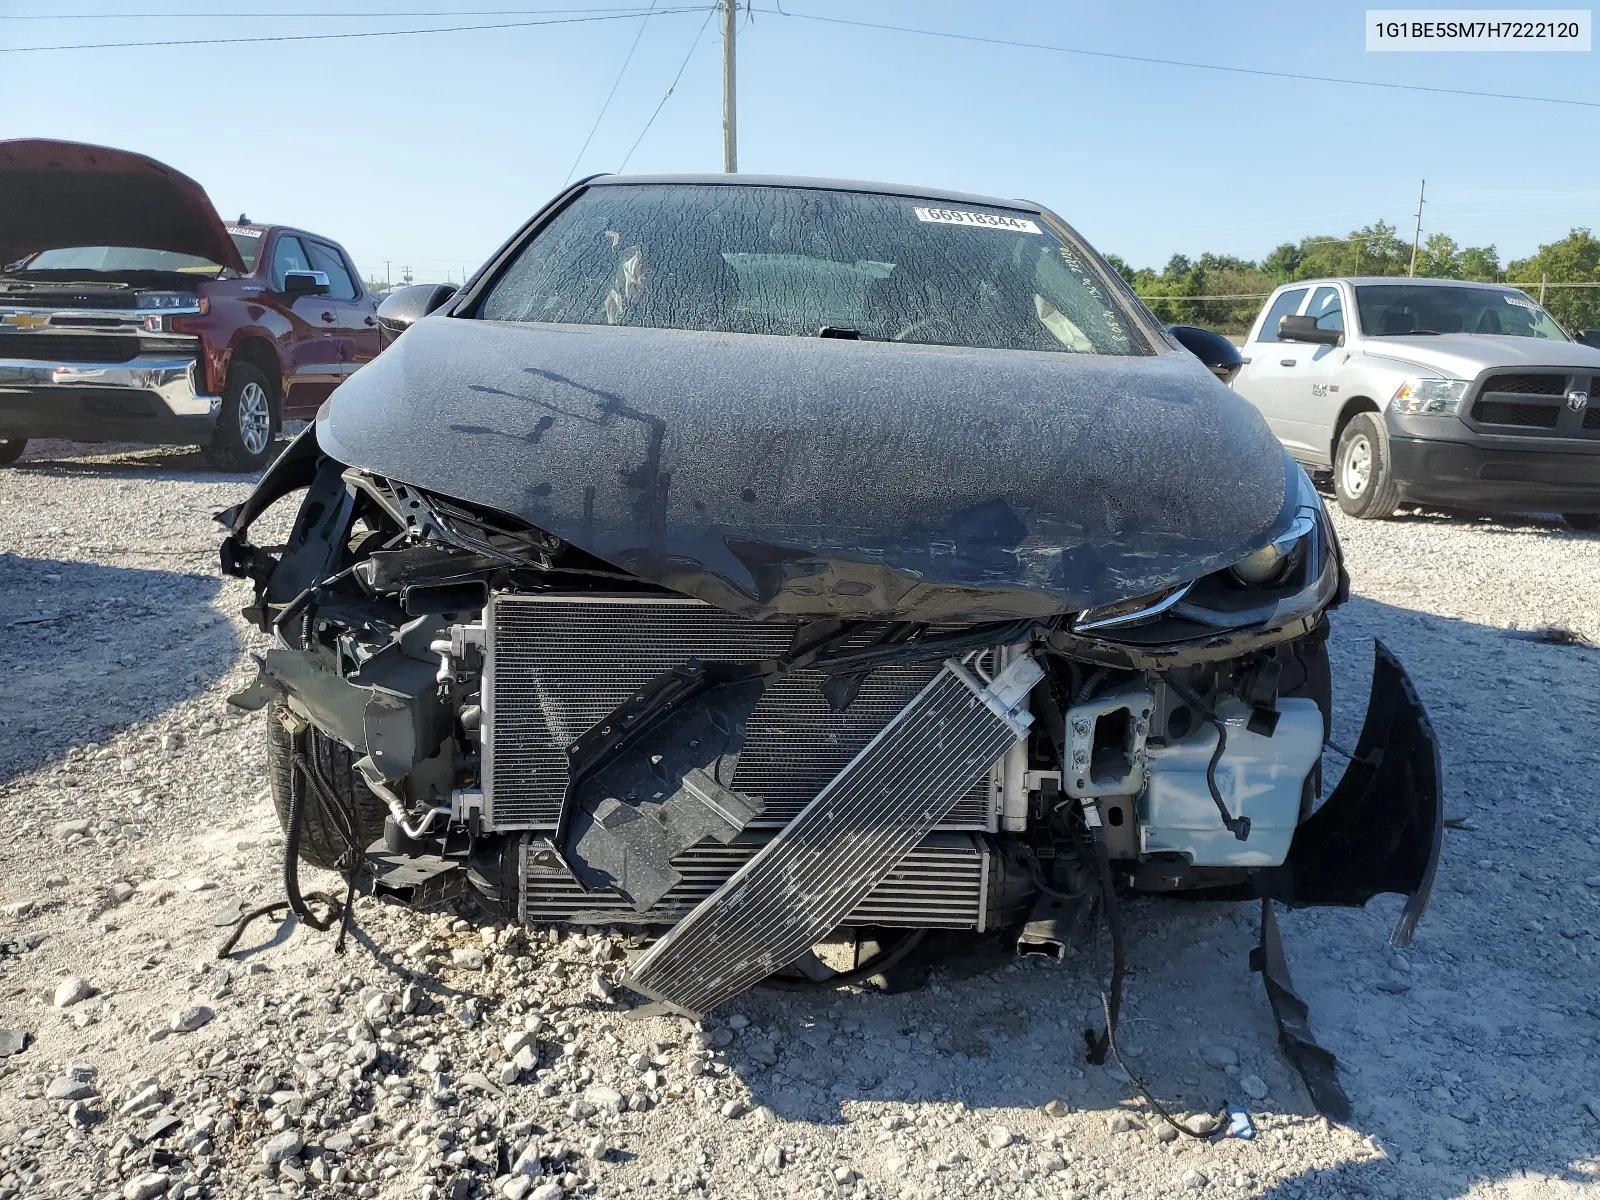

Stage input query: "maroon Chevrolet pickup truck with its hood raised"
[{"left": 0, "top": 139, "right": 382, "bottom": 470}]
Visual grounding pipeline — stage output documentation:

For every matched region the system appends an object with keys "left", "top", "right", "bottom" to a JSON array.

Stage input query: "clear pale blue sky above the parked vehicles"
[{"left": 0, "top": 0, "right": 1600, "bottom": 278}]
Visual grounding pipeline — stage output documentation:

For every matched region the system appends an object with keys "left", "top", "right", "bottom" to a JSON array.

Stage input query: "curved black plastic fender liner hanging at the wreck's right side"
[{"left": 1256, "top": 642, "right": 1445, "bottom": 946}]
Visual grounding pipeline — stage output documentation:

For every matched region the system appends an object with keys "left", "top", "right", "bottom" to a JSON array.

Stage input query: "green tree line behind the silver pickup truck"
[{"left": 1106, "top": 221, "right": 1600, "bottom": 333}]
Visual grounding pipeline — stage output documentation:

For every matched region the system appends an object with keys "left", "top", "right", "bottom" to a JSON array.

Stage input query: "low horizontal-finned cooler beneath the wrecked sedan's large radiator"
[{"left": 522, "top": 834, "right": 990, "bottom": 931}]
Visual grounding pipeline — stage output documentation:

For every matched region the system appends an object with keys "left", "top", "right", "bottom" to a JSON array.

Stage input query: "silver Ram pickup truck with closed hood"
[{"left": 1234, "top": 277, "right": 1600, "bottom": 530}]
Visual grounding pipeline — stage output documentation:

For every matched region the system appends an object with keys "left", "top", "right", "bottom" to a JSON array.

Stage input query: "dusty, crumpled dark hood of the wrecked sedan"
[{"left": 317, "top": 315, "right": 1293, "bottom": 622}]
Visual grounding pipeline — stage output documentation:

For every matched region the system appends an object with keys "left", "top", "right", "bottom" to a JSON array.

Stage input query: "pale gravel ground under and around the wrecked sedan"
[{"left": 0, "top": 445, "right": 1600, "bottom": 1200}]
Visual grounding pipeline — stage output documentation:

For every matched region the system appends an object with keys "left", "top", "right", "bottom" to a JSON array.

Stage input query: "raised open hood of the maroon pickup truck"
[{"left": 0, "top": 138, "right": 245, "bottom": 274}]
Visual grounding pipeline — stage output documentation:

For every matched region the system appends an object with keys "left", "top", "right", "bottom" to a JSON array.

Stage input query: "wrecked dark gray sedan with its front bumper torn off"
[{"left": 221, "top": 176, "right": 1442, "bottom": 1109}]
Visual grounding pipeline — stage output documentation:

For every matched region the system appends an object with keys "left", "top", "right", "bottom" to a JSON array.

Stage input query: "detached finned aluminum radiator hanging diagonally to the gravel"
[{"left": 626, "top": 658, "right": 1043, "bottom": 1014}]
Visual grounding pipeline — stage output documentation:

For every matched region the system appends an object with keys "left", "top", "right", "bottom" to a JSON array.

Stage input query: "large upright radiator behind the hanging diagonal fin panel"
[{"left": 483, "top": 595, "right": 992, "bottom": 830}]
